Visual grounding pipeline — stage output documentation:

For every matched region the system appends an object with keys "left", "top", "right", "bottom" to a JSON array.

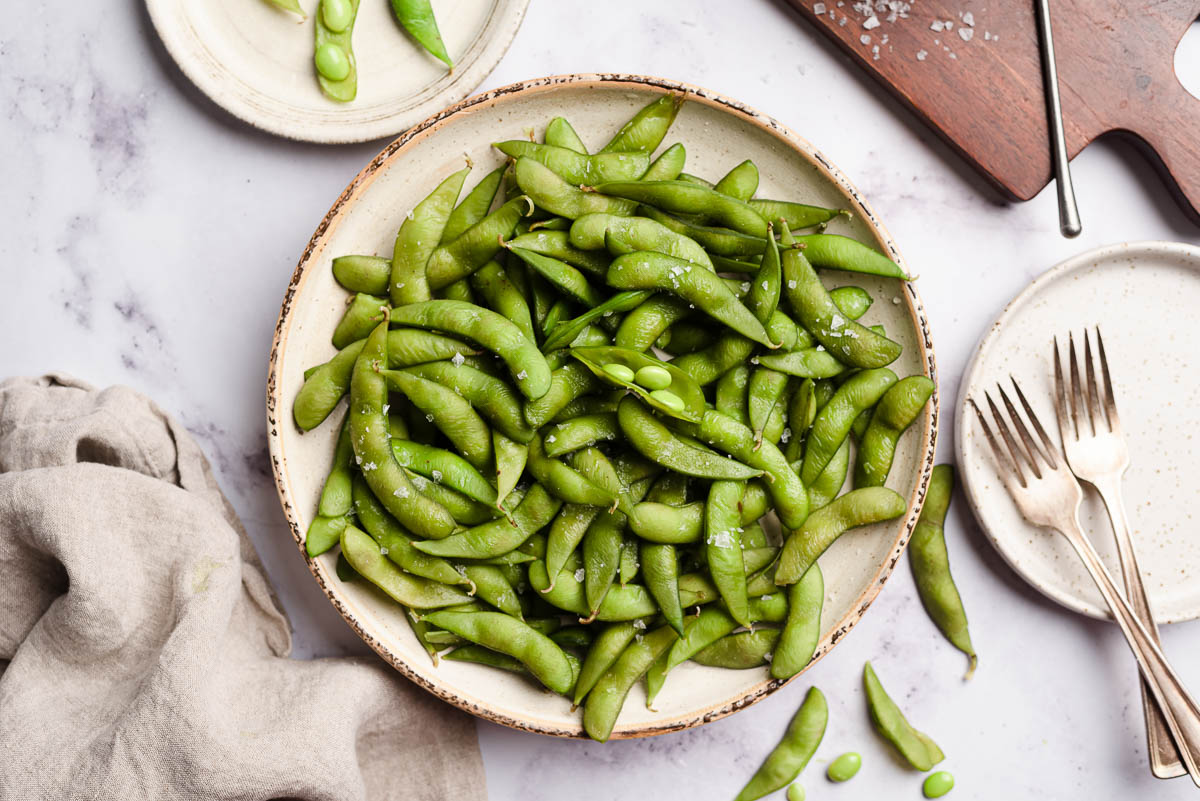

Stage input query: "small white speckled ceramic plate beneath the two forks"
[{"left": 955, "top": 242, "right": 1200, "bottom": 624}]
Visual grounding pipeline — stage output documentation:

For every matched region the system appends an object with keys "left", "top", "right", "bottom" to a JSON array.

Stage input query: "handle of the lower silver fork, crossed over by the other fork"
[{"left": 1092, "top": 478, "right": 1187, "bottom": 778}]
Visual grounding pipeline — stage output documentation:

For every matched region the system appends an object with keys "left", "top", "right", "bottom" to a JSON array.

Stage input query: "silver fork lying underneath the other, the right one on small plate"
[{"left": 1054, "top": 327, "right": 1186, "bottom": 778}]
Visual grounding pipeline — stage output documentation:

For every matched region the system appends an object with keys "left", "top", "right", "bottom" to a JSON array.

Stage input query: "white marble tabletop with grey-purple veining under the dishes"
[{"left": 7, "top": 0, "right": 1200, "bottom": 801}]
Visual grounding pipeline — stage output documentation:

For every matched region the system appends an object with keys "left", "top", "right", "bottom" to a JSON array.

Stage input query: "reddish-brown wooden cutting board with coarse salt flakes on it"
[{"left": 788, "top": 0, "right": 1200, "bottom": 223}]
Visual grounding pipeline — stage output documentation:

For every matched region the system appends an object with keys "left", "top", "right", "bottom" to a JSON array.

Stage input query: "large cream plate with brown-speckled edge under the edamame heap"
[{"left": 268, "top": 76, "right": 937, "bottom": 737}]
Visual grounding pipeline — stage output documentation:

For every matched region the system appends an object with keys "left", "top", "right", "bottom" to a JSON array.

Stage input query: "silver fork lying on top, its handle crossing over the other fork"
[{"left": 967, "top": 380, "right": 1200, "bottom": 787}]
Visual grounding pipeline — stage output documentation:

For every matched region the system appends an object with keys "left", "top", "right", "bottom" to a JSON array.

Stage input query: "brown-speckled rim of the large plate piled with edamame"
[{"left": 266, "top": 73, "right": 940, "bottom": 739}]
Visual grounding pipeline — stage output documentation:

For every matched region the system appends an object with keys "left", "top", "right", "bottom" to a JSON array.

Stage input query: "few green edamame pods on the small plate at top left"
[{"left": 266, "top": 0, "right": 454, "bottom": 103}]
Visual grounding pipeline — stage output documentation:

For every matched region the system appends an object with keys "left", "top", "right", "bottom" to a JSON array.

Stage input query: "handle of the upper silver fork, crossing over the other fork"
[{"left": 1062, "top": 519, "right": 1200, "bottom": 787}]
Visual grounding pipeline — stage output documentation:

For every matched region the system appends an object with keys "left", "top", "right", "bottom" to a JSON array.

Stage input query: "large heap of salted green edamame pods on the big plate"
[{"left": 300, "top": 94, "right": 964, "bottom": 741}]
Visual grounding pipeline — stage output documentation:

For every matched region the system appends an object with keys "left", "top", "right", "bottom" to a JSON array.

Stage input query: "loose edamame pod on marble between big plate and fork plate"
[{"left": 908, "top": 464, "right": 978, "bottom": 679}]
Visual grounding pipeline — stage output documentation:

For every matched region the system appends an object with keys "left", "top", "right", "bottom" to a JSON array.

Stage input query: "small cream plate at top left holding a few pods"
[{"left": 146, "top": 0, "right": 529, "bottom": 143}]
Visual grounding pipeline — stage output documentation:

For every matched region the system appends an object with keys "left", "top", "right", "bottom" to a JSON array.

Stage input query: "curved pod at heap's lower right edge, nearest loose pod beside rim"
[{"left": 775, "top": 487, "right": 907, "bottom": 586}]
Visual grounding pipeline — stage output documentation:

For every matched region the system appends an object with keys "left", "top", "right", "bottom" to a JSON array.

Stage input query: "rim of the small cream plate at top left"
[{"left": 144, "top": 0, "right": 529, "bottom": 145}]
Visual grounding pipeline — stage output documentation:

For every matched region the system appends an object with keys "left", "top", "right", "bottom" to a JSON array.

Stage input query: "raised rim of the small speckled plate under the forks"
[{"left": 954, "top": 240, "right": 1200, "bottom": 625}]
